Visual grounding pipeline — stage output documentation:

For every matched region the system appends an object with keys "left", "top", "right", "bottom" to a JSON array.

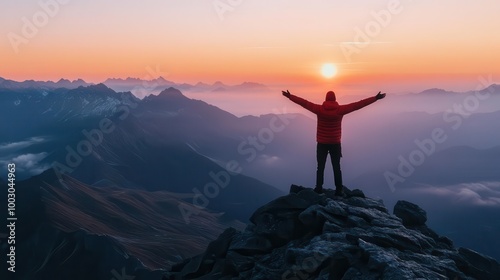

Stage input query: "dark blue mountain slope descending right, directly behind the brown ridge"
[{"left": 48, "top": 110, "right": 282, "bottom": 221}]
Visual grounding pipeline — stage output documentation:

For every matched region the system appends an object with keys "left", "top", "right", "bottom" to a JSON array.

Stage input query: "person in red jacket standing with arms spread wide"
[{"left": 282, "top": 90, "right": 385, "bottom": 196}]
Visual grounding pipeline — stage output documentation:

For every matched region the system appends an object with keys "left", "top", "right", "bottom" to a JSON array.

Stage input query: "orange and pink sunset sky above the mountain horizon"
[{"left": 0, "top": 0, "right": 500, "bottom": 91}]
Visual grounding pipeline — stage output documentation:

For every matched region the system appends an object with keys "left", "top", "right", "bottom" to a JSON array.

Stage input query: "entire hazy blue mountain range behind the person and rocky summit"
[{"left": 0, "top": 79, "right": 500, "bottom": 279}]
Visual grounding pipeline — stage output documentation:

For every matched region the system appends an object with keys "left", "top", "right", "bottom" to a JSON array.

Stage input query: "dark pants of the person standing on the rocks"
[{"left": 316, "top": 143, "right": 342, "bottom": 190}]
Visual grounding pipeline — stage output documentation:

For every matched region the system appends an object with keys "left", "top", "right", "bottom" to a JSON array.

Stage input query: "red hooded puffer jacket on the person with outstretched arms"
[{"left": 289, "top": 92, "right": 377, "bottom": 144}]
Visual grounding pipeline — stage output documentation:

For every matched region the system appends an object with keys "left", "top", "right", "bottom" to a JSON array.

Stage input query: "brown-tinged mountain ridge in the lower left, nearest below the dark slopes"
[{"left": 1, "top": 170, "right": 243, "bottom": 279}]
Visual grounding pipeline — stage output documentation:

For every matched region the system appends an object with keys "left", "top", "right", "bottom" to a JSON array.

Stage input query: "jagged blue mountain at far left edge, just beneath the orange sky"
[{"left": 0, "top": 84, "right": 138, "bottom": 143}]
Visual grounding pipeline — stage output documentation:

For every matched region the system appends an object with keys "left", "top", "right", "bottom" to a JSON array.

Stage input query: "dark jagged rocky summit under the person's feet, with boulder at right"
[{"left": 163, "top": 185, "right": 500, "bottom": 280}]
